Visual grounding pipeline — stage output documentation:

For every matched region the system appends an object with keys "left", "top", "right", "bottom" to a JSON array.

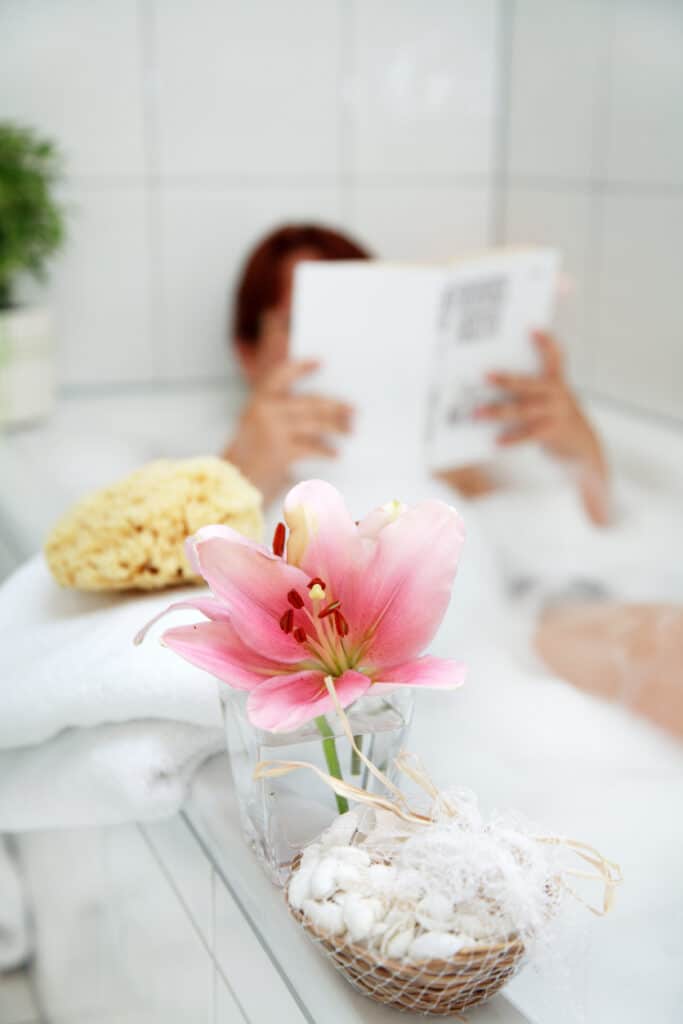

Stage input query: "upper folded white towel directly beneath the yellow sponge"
[{"left": 0, "top": 556, "right": 221, "bottom": 753}]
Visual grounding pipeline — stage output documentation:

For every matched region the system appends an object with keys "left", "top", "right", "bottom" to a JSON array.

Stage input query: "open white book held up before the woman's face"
[{"left": 291, "top": 248, "right": 560, "bottom": 470}]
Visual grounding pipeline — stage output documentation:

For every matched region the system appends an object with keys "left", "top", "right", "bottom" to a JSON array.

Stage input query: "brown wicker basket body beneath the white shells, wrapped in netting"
[{"left": 286, "top": 858, "right": 524, "bottom": 1017}]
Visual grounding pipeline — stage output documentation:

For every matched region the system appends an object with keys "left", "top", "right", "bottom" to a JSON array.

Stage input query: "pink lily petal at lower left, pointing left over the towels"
[{"left": 162, "top": 622, "right": 296, "bottom": 690}]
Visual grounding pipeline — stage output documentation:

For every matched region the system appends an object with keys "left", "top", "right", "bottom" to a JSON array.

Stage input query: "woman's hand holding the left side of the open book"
[{"left": 223, "top": 360, "right": 353, "bottom": 502}]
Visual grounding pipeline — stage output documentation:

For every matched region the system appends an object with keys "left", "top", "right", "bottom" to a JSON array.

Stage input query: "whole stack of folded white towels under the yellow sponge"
[{"left": 0, "top": 556, "right": 223, "bottom": 833}]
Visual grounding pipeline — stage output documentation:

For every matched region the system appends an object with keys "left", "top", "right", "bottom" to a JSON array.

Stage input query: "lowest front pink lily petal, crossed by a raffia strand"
[{"left": 247, "top": 671, "right": 371, "bottom": 732}]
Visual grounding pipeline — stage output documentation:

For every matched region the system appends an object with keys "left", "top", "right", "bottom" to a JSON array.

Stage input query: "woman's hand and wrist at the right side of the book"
[{"left": 475, "top": 331, "right": 609, "bottom": 524}]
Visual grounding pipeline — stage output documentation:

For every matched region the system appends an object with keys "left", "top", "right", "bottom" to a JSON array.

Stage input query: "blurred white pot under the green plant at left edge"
[{"left": 0, "top": 308, "right": 54, "bottom": 426}]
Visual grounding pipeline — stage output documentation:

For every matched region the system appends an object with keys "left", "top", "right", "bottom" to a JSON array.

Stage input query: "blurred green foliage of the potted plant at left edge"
[{"left": 0, "top": 121, "right": 65, "bottom": 309}]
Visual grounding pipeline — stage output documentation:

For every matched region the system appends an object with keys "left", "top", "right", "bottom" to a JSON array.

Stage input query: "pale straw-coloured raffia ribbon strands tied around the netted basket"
[{"left": 254, "top": 676, "right": 624, "bottom": 916}]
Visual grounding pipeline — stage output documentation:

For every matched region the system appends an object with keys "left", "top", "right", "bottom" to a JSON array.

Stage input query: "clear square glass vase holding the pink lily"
[{"left": 219, "top": 683, "right": 413, "bottom": 886}]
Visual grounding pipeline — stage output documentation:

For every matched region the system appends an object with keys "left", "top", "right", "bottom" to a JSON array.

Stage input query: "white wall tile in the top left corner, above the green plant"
[{"left": 0, "top": 0, "right": 144, "bottom": 178}]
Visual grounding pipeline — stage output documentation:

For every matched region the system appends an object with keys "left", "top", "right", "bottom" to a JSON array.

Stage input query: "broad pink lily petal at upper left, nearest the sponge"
[{"left": 193, "top": 526, "right": 308, "bottom": 665}]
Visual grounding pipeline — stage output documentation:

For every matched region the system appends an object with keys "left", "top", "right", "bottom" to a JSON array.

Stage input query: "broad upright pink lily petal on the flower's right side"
[{"left": 358, "top": 501, "right": 465, "bottom": 667}]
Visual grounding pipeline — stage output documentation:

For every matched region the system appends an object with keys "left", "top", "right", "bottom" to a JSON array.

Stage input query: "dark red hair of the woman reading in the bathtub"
[{"left": 232, "top": 224, "right": 370, "bottom": 345}]
